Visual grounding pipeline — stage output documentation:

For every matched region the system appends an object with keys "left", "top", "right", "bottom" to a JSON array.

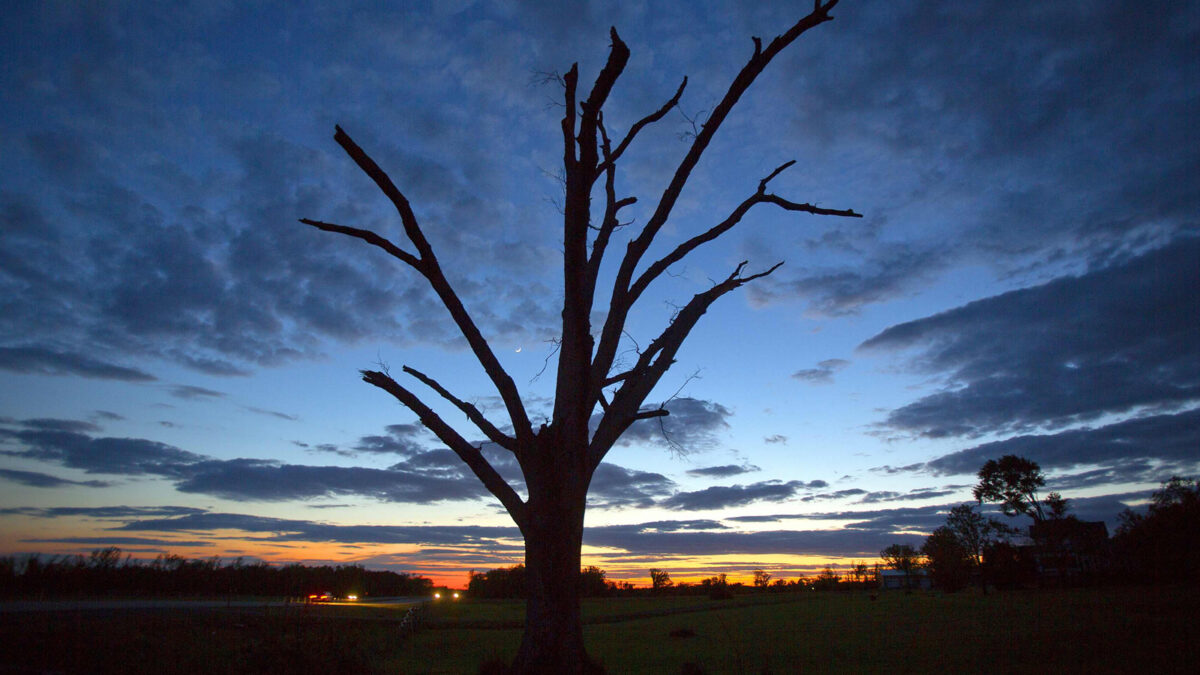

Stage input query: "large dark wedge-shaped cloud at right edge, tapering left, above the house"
[{"left": 859, "top": 237, "right": 1200, "bottom": 437}]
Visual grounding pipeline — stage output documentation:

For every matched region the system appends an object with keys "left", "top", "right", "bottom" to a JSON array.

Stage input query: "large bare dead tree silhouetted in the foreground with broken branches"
[{"left": 301, "top": 0, "right": 859, "bottom": 673}]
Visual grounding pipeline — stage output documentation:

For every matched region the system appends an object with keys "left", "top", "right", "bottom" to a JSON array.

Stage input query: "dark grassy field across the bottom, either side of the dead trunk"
[{"left": 0, "top": 587, "right": 1200, "bottom": 675}]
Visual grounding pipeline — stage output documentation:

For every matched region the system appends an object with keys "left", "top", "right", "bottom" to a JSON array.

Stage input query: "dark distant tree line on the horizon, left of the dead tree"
[{"left": 0, "top": 546, "right": 433, "bottom": 597}]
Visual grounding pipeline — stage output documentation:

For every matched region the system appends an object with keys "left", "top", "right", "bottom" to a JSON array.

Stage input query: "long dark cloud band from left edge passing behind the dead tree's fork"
[{"left": 0, "top": 420, "right": 676, "bottom": 508}]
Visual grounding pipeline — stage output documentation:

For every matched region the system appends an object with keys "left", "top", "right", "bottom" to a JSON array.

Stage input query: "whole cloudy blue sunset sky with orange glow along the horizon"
[{"left": 0, "top": 0, "right": 1200, "bottom": 585}]
